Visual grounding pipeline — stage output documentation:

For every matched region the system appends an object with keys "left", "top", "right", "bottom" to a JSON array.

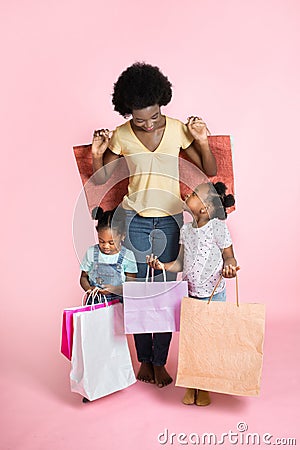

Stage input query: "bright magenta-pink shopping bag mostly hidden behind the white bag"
[{"left": 60, "top": 292, "right": 119, "bottom": 361}]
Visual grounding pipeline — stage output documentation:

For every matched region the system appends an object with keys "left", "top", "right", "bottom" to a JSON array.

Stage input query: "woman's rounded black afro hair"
[{"left": 112, "top": 62, "right": 172, "bottom": 117}]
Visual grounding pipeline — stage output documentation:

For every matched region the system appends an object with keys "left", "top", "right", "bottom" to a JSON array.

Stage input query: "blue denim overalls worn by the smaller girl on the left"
[{"left": 87, "top": 245, "right": 126, "bottom": 304}]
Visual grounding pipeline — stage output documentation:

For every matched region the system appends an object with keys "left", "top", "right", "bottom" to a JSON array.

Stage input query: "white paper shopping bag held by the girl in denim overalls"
[{"left": 70, "top": 303, "right": 136, "bottom": 400}]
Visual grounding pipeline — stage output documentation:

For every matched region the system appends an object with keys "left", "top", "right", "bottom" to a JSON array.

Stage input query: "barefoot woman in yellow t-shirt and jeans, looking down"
[{"left": 92, "top": 63, "right": 216, "bottom": 387}]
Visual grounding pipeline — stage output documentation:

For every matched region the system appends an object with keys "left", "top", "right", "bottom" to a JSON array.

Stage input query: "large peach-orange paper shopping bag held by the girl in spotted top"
[{"left": 176, "top": 278, "right": 265, "bottom": 396}]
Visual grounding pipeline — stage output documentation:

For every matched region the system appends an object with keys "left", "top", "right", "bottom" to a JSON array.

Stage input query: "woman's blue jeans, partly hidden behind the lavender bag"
[{"left": 125, "top": 210, "right": 183, "bottom": 366}]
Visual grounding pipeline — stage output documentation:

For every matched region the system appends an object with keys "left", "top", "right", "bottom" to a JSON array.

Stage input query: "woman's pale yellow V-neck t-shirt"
[{"left": 109, "top": 117, "right": 193, "bottom": 217}]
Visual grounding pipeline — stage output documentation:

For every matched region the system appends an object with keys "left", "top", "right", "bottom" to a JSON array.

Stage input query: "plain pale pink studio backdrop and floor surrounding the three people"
[{"left": 0, "top": 0, "right": 300, "bottom": 450}]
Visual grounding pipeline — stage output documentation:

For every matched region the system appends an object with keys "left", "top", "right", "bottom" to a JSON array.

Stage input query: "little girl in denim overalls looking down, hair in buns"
[{"left": 80, "top": 207, "right": 137, "bottom": 304}]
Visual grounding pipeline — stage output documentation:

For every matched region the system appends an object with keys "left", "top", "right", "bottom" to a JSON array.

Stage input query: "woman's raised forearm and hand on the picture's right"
[{"left": 185, "top": 117, "right": 217, "bottom": 177}]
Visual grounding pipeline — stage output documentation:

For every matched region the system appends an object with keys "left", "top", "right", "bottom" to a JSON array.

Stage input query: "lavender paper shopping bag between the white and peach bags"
[{"left": 123, "top": 272, "right": 188, "bottom": 334}]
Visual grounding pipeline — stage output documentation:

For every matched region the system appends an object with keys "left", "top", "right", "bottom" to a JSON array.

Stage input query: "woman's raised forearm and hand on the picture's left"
[{"left": 92, "top": 129, "right": 120, "bottom": 184}]
